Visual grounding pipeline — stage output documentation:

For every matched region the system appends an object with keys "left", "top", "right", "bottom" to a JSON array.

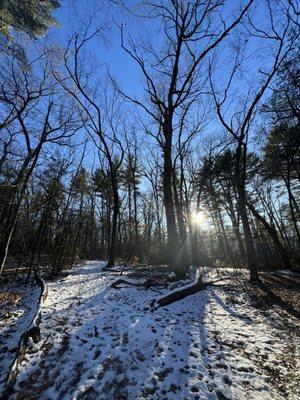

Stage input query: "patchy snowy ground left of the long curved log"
[{"left": 0, "top": 281, "right": 41, "bottom": 394}]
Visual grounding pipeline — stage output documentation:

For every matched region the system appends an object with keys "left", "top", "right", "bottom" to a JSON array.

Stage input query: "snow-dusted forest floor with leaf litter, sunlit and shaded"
[{"left": 0, "top": 261, "right": 300, "bottom": 400}]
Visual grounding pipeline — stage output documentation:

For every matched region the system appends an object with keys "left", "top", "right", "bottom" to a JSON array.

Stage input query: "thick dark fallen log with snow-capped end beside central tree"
[{"left": 151, "top": 270, "right": 208, "bottom": 307}]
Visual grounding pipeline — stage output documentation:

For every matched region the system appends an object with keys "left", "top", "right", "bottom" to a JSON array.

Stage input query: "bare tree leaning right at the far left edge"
[{"left": 0, "top": 46, "right": 78, "bottom": 272}]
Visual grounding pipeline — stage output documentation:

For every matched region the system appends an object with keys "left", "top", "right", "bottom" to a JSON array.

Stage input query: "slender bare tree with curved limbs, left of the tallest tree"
[{"left": 54, "top": 25, "right": 124, "bottom": 268}]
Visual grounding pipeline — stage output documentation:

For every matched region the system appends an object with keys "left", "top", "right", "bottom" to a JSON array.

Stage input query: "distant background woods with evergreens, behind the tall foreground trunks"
[{"left": 3, "top": 123, "right": 299, "bottom": 273}]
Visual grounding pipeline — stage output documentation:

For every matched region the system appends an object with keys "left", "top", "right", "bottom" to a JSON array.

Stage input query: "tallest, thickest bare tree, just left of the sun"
[{"left": 113, "top": 0, "right": 253, "bottom": 276}]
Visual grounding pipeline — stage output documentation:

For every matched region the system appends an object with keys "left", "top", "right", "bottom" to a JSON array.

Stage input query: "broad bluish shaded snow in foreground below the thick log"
[{"left": 12, "top": 272, "right": 225, "bottom": 400}]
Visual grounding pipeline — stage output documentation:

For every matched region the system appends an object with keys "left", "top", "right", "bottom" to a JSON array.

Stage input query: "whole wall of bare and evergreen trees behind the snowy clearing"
[{"left": 0, "top": 0, "right": 300, "bottom": 280}]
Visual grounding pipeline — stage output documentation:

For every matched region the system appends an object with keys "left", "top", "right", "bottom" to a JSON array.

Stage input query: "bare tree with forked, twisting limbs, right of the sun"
[{"left": 209, "top": 1, "right": 299, "bottom": 281}]
